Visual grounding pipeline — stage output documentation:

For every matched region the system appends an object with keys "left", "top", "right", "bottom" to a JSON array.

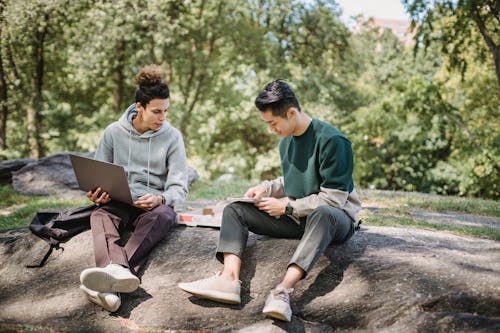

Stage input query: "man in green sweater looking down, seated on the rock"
[{"left": 179, "top": 80, "right": 361, "bottom": 321}]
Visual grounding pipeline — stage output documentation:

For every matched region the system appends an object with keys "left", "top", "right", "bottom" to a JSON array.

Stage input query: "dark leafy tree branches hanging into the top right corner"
[{"left": 403, "top": 0, "right": 500, "bottom": 89}]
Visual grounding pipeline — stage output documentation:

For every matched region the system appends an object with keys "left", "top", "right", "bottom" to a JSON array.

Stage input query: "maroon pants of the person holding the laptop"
[{"left": 90, "top": 202, "right": 176, "bottom": 275}]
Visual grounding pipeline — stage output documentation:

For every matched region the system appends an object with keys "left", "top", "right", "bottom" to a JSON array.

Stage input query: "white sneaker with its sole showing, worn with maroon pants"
[{"left": 80, "top": 264, "right": 140, "bottom": 293}]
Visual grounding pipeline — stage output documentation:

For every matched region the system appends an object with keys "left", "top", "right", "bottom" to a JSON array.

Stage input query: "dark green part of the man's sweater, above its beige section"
[{"left": 279, "top": 119, "right": 354, "bottom": 199}]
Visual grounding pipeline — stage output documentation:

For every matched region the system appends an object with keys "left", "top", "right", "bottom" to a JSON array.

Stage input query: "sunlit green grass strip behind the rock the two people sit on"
[{"left": 0, "top": 180, "right": 500, "bottom": 240}]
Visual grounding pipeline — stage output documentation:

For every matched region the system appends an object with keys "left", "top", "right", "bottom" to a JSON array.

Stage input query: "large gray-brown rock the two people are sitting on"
[{"left": 0, "top": 226, "right": 500, "bottom": 333}]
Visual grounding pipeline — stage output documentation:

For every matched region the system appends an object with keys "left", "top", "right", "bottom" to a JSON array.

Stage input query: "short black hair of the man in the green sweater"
[{"left": 255, "top": 79, "right": 300, "bottom": 118}]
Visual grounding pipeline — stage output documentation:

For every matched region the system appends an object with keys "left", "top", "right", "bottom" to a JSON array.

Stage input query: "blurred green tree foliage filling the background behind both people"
[{"left": 0, "top": 0, "right": 500, "bottom": 199}]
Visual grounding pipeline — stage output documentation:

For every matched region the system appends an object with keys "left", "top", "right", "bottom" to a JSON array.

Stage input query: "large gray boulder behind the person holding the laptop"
[{"left": 12, "top": 152, "right": 199, "bottom": 198}]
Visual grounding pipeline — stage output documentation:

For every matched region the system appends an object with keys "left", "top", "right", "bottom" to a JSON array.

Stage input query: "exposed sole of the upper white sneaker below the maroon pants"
[{"left": 80, "top": 270, "right": 139, "bottom": 293}]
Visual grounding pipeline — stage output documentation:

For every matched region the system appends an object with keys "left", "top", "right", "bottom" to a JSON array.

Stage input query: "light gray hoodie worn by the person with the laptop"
[{"left": 95, "top": 104, "right": 188, "bottom": 205}]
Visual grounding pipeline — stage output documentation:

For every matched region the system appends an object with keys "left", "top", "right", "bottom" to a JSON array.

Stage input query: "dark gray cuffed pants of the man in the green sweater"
[{"left": 216, "top": 202, "right": 354, "bottom": 277}]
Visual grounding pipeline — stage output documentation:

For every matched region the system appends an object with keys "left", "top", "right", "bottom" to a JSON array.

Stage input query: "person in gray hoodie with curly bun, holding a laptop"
[{"left": 80, "top": 65, "right": 188, "bottom": 312}]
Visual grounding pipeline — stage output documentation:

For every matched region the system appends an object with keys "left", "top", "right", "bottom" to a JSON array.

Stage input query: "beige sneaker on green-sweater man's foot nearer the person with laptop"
[{"left": 178, "top": 272, "right": 241, "bottom": 304}]
